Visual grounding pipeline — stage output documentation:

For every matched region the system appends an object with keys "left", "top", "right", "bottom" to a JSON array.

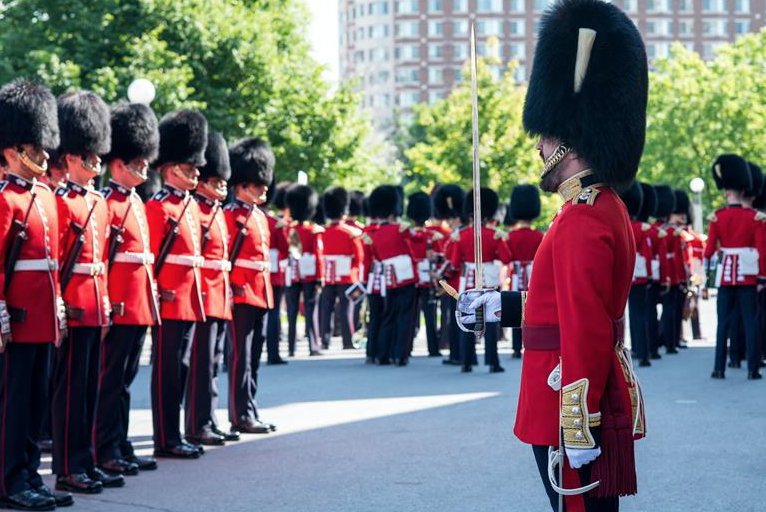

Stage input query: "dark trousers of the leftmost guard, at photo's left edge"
[{"left": 0, "top": 342, "right": 53, "bottom": 497}]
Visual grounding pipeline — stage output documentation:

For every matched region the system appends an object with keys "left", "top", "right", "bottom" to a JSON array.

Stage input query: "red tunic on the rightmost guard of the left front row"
[{"left": 224, "top": 200, "right": 274, "bottom": 309}]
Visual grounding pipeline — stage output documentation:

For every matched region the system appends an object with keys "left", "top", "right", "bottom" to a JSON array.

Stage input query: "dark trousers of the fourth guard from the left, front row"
[{"left": 151, "top": 320, "right": 195, "bottom": 449}]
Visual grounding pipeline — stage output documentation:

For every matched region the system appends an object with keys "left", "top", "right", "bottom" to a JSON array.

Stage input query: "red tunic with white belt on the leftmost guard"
[{"left": 0, "top": 174, "right": 61, "bottom": 343}]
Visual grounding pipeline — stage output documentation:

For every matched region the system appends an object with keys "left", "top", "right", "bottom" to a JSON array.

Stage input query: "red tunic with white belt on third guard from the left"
[{"left": 101, "top": 182, "right": 160, "bottom": 325}]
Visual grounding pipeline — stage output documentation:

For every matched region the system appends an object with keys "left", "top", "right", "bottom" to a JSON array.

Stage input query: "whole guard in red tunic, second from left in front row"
[{"left": 51, "top": 91, "right": 125, "bottom": 494}]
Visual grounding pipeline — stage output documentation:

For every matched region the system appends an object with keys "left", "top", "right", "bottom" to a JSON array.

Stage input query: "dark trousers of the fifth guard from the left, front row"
[{"left": 184, "top": 317, "right": 227, "bottom": 437}]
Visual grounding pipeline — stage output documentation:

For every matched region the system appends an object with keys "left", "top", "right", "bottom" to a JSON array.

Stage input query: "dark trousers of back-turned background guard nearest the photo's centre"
[{"left": 377, "top": 284, "right": 415, "bottom": 361}]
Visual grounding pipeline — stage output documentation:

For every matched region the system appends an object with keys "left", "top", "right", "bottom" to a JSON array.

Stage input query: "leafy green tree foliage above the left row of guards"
[{"left": 0, "top": 0, "right": 380, "bottom": 187}]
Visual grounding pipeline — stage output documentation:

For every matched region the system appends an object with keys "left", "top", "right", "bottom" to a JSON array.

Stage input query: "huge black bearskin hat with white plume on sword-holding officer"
[{"left": 524, "top": 0, "right": 648, "bottom": 192}]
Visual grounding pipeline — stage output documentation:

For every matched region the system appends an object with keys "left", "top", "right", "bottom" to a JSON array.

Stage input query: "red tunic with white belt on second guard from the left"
[{"left": 56, "top": 182, "right": 111, "bottom": 327}]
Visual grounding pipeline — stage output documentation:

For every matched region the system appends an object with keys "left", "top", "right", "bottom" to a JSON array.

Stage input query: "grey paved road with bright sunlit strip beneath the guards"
[{"left": 40, "top": 298, "right": 766, "bottom": 512}]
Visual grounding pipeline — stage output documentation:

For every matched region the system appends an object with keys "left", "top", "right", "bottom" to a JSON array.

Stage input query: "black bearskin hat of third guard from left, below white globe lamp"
[{"left": 104, "top": 103, "right": 160, "bottom": 163}]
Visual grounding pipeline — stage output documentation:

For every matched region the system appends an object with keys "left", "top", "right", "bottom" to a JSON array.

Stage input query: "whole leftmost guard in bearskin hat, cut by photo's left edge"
[{"left": 0, "top": 80, "right": 72, "bottom": 510}]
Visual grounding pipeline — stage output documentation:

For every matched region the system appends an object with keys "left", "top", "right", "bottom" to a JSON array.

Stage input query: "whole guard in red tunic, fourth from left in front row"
[{"left": 146, "top": 110, "right": 207, "bottom": 459}]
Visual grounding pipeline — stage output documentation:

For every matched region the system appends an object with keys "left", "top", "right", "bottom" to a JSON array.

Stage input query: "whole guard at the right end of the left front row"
[{"left": 225, "top": 138, "right": 276, "bottom": 434}]
